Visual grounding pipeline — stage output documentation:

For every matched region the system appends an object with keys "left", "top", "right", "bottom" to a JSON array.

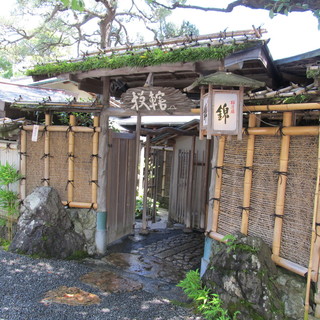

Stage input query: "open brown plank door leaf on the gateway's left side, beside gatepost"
[{"left": 107, "top": 132, "right": 136, "bottom": 244}]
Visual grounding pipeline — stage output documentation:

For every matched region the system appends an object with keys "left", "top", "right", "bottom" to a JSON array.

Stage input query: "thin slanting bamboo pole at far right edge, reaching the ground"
[{"left": 304, "top": 125, "right": 320, "bottom": 320}]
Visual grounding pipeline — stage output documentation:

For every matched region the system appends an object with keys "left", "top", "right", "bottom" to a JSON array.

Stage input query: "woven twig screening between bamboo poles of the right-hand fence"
[{"left": 216, "top": 136, "right": 318, "bottom": 267}]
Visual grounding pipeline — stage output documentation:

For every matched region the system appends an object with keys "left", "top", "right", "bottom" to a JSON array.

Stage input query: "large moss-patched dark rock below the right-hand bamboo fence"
[{"left": 203, "top": 234, "right": 303, "bottom": 320}]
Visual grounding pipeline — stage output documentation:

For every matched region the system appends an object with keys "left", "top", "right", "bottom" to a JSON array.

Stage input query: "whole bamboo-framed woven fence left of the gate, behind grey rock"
[{"left": 20, "top": 117, "right": 101, "bottom": 209}]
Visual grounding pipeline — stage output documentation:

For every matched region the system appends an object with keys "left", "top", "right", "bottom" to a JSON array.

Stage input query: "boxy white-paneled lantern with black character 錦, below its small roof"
[{"left": 200, "top": 90, "right": 242, "bottom": 139}]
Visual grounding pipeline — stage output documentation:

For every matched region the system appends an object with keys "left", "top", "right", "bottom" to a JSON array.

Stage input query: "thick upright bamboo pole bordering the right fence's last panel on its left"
[{"left": 272, "top": 112, "right": 292, "bottom": 256}]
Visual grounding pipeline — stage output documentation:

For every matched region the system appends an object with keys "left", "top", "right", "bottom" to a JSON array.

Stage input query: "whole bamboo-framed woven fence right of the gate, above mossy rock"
[{"left": 208, "top": 110, "right": 320, "bottom": 281}]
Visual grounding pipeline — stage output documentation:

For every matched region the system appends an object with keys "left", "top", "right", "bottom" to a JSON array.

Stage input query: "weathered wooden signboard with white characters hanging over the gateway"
[{"left": 121, "top": 87, "right": 195, "bottom": 113}]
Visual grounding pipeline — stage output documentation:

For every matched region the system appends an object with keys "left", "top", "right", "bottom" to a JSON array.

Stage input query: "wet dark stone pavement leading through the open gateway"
[{"left": 85, "top": 228, "right": 204, "bottom": 302}]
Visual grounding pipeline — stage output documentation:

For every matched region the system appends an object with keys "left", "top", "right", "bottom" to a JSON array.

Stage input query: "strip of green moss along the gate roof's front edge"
[{"left": 26, "top": 41, "right": 260, "bottom": 77}]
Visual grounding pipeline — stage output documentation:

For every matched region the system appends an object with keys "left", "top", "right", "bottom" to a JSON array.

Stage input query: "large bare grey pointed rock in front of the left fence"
[{"left": 9, "top": 187, "right": 84, "bottom": 258}]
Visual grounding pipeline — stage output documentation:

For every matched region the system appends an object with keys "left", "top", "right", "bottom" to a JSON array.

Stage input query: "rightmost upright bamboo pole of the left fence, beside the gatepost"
[{"left": 91, "top": 116, "right": 99, "bottom": 203}]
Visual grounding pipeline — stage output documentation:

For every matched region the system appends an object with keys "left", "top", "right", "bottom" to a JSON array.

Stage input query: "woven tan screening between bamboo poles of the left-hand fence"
[{"left": 22, "top": 131, "right": 92, "bottom": 207}]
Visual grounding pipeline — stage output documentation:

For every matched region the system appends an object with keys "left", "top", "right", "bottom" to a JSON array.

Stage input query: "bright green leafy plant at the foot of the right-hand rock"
[{"left": 178, "top": 270, "right": 239, "bottom": 320}]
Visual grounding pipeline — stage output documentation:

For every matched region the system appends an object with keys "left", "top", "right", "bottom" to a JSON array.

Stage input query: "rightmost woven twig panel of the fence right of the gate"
[{"left": 280, "top": 136, "right": 318, "bottom": 267}]
